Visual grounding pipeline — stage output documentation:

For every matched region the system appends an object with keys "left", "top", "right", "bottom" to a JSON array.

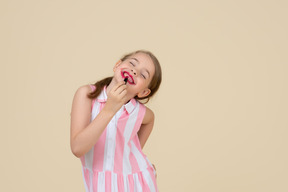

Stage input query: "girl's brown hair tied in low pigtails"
[{"left": 87, "top": 50, "right": 162, "bottom": 103}]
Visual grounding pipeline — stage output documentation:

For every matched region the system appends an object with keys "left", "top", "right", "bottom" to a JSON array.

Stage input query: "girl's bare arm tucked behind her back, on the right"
[{"left": 138, "top": 107, "right": 154, "bottom": 148}]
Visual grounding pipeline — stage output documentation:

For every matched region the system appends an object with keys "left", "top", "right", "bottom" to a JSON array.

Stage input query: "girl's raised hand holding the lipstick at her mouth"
[{"left": 105, "top": 81, "right": 127, "bottom": 113}]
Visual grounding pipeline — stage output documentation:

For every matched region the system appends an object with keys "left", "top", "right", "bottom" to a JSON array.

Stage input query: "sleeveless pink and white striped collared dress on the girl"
[{"left": 80, "top": 85, "right": 158, "bottom": 192}]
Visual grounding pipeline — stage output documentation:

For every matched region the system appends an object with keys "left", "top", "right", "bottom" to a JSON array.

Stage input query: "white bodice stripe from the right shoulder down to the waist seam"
[{"left": 123, "top": 103, "right": 140, "bottom": 175}]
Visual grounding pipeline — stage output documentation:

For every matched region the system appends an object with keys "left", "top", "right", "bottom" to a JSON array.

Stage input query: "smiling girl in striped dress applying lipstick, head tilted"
[{"left": 70, "top": 50, "right": 162, "bottom": 192}]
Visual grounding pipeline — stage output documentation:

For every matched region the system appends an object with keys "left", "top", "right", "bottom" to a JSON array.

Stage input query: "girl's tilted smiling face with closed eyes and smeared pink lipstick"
[{"left": 114, "top": 53, "right": 155, "bottom": 97}]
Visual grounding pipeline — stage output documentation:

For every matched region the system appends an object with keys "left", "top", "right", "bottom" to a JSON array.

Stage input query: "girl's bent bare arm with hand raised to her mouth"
[{"left": 70, "top": 82, "right": 127, "bottom": 157}]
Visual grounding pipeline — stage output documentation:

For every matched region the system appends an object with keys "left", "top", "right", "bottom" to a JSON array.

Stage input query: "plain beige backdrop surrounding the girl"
[{"left": 0, "top": 0, "right": 288, "bottom": 192}]
